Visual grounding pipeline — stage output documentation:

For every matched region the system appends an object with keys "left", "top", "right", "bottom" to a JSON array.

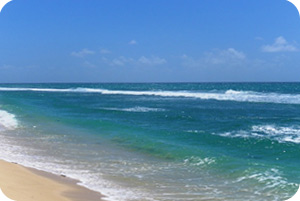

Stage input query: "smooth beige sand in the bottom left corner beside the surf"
[{"left": 0, "top": 160, "right": 102, "bottom": 201}]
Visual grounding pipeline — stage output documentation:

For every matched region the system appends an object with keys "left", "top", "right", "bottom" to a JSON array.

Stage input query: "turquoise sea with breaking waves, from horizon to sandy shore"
[{"left": 0, "top": 83, "right": 300, "bottom": 201}]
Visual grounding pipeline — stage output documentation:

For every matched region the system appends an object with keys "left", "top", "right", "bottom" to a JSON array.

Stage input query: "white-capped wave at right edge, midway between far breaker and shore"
[{"left": 220, "top": 125, "right": 300, "bottom": 144}]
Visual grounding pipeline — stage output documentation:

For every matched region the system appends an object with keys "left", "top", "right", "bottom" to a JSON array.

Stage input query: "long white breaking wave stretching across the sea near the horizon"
[{"left": 0, "top": 87, "right": 300, "bottom": 104}]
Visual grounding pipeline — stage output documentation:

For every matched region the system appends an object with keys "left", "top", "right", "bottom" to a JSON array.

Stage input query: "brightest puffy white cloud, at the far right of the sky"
[{"left": 262, "top": 36, "right": 298, "bottom": 52}]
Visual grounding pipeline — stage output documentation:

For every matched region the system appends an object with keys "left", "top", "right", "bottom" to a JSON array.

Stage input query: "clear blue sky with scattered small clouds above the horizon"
[{"left": 0, "top": 0, "right": 300, "bottom": 83}]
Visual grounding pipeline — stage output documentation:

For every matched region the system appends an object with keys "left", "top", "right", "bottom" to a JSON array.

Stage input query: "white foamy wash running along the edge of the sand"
[{"left": 0, "top": 132, "right": 153, "bottom": 201}]
